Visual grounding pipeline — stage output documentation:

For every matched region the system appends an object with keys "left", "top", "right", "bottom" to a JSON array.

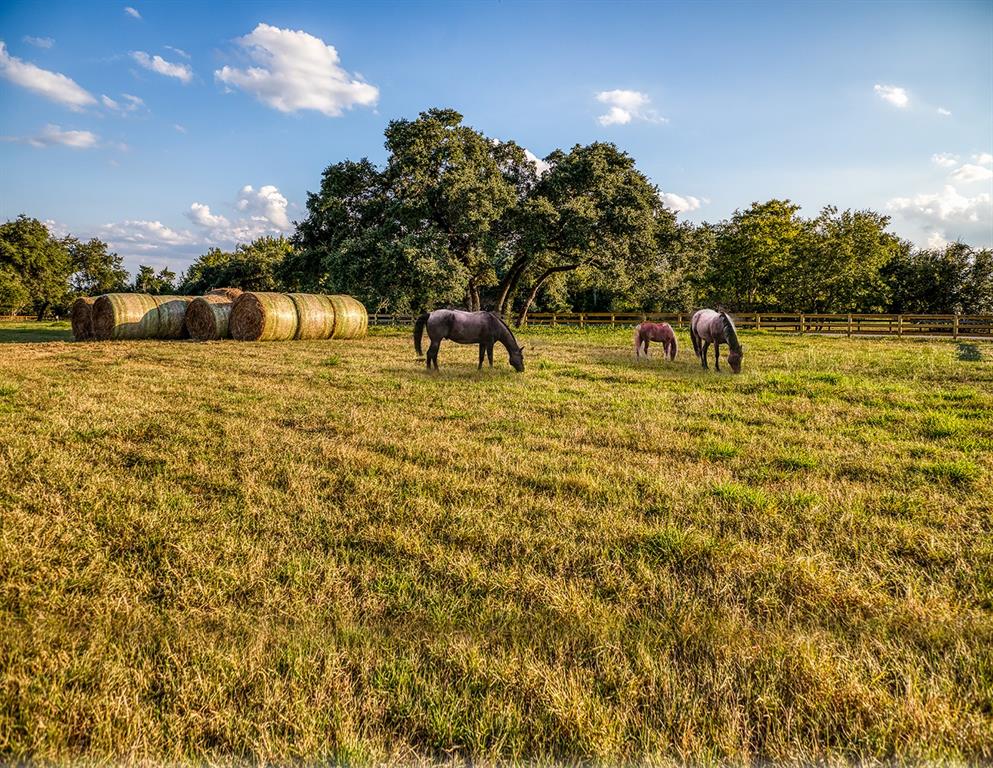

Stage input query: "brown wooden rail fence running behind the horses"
[{"left": 369, "top": 312, "right": 993, "bottom": 339}]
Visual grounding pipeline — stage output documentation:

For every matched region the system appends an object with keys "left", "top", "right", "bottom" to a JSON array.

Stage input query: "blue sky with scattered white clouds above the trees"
[{"left": 0, "top": 0, "right": 993, "bottom": 272}]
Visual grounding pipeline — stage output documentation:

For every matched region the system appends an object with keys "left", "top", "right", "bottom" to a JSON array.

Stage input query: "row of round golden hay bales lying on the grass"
[{"left": 71, "top": 288, "right": 369, "bottom": 341}]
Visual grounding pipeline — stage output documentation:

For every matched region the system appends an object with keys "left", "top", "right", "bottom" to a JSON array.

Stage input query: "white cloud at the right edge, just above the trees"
[{"left": 887, "top": 184, "right": 993, "bottom": 247}]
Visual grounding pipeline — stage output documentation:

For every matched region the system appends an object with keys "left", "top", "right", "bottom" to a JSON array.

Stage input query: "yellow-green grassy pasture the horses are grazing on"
[{"left": 0, "top": 323, "right": 993, "bottom": 763}]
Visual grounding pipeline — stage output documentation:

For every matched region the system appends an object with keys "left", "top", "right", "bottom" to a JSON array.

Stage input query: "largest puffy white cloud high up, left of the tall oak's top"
[{"left": 214, "top": 24, "right": 379, "bottom": 117}]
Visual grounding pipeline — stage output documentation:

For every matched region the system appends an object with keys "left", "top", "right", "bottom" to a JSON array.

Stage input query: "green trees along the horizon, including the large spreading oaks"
[{"left": 0, "top": 109, "right": 993, "bottom": 320}]
